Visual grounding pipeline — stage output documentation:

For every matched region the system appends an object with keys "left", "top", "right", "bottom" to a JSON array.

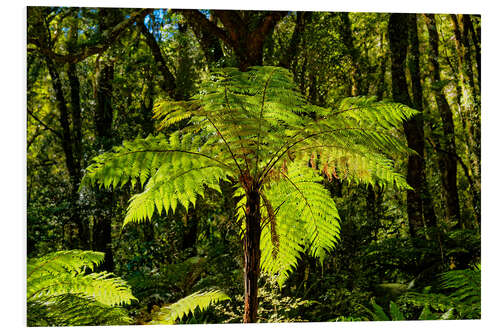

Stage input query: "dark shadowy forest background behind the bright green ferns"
[{"left": 19, "top": 2, "right": 481, "bottom": 325}]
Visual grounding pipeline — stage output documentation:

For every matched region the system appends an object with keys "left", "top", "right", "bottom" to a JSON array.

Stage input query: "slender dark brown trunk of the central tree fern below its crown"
[{"left": 243, "top": 190, "right": 261, "bottom": 323}]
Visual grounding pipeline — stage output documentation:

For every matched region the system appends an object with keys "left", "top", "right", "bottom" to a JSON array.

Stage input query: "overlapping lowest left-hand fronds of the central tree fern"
[{"left": 82, "top": 131, "right": 230, "bottom": 225}]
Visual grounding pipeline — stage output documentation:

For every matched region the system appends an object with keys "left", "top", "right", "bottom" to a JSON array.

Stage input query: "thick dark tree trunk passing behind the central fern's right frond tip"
[{"left": 388, "top": 14, "right": 424, "bottom": 237}]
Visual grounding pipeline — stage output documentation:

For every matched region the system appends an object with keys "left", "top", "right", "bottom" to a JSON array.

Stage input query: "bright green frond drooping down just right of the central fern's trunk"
[{"left": 261, "top": 163, "right": 340, "bottom": 285}]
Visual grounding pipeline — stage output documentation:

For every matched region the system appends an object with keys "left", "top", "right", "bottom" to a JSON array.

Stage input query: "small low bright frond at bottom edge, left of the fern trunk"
[{"left": 150, "top": 289, "right": 229, "bottom": 324}]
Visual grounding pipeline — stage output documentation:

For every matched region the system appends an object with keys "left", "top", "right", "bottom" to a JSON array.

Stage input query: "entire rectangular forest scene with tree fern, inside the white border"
[{"left": 26, "top": 7, "right": 481, "bottom": 326}]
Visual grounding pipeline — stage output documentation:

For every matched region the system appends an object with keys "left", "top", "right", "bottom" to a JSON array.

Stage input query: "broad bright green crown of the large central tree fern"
[{"left": 82, "top": 67, "right": 416, "bottom": 322}]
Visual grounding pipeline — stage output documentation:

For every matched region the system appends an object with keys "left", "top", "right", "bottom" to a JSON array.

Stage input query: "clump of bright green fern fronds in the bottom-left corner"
[{"left": 27, "top": 250, "right": 136, "bottom": 326}]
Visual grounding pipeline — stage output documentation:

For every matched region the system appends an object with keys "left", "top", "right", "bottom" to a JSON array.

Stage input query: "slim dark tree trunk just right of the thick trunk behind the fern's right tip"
[{"left": 424, "top": 14, "right": 460, "bottom": 226}]
